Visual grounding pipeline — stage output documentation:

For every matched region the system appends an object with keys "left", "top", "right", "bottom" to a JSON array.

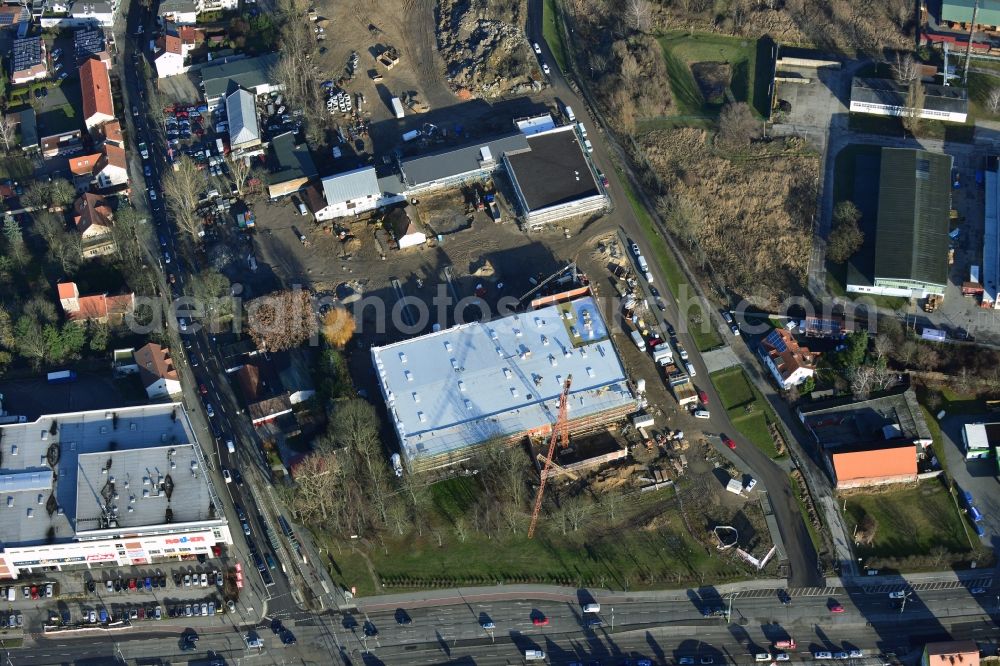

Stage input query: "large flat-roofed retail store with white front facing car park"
[{"left": 0, "top": 403, "right": 232, "bottom": 578}]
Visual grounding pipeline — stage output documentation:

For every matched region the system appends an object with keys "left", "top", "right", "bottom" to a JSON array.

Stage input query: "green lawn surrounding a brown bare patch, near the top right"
[{"left": 659, "top": 32, "right": 766, "bottom": 118}]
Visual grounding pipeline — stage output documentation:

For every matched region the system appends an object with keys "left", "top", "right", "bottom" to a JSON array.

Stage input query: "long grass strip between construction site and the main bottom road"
[{"left": 320, "top": 477, "right": 746, "bottom": 596}]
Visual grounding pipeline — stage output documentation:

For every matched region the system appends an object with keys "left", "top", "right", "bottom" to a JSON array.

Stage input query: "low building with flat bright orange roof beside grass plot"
[{"left": 827, "top": 440, "right": 917, "bottom": 490}]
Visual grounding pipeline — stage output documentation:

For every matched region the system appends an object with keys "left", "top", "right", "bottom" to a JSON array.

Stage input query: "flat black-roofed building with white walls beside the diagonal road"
[{"left": 503, "top": 124, "right": 608, "bottom": 227}]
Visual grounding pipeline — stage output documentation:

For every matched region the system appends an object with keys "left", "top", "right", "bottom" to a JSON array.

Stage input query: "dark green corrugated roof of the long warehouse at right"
[{"left": 875, "top": 148, "right": 952, "bottom": 285}]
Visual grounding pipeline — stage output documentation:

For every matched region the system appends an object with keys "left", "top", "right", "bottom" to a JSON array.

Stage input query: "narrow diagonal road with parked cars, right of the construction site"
[{"left": 528, "top": 0, "right": 823, "bottom": 587}]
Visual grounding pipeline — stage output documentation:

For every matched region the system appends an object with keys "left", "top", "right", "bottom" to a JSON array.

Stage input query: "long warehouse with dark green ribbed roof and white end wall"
[{"left": 847, "top": 148, "right": 952, "bottom": 298}]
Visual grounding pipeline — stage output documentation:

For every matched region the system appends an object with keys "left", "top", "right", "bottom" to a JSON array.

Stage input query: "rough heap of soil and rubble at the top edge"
[{"left": 436, "top": 0, "right": 540, "bottom": 98}]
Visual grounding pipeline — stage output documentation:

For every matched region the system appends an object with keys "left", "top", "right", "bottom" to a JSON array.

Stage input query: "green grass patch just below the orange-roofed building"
[{"left": 845, "top": 479, "right": 970, "bottom": 558}]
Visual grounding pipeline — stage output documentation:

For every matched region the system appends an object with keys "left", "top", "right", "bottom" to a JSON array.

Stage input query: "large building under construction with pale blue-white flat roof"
[{"left": 372, "top": 295, "right": 636, "bottom": 471}]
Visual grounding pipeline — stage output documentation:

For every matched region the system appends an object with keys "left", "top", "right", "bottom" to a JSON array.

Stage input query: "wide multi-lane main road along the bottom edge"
[{"left": 17, "top": 579, "right": 1000, "bottom": 666}]
